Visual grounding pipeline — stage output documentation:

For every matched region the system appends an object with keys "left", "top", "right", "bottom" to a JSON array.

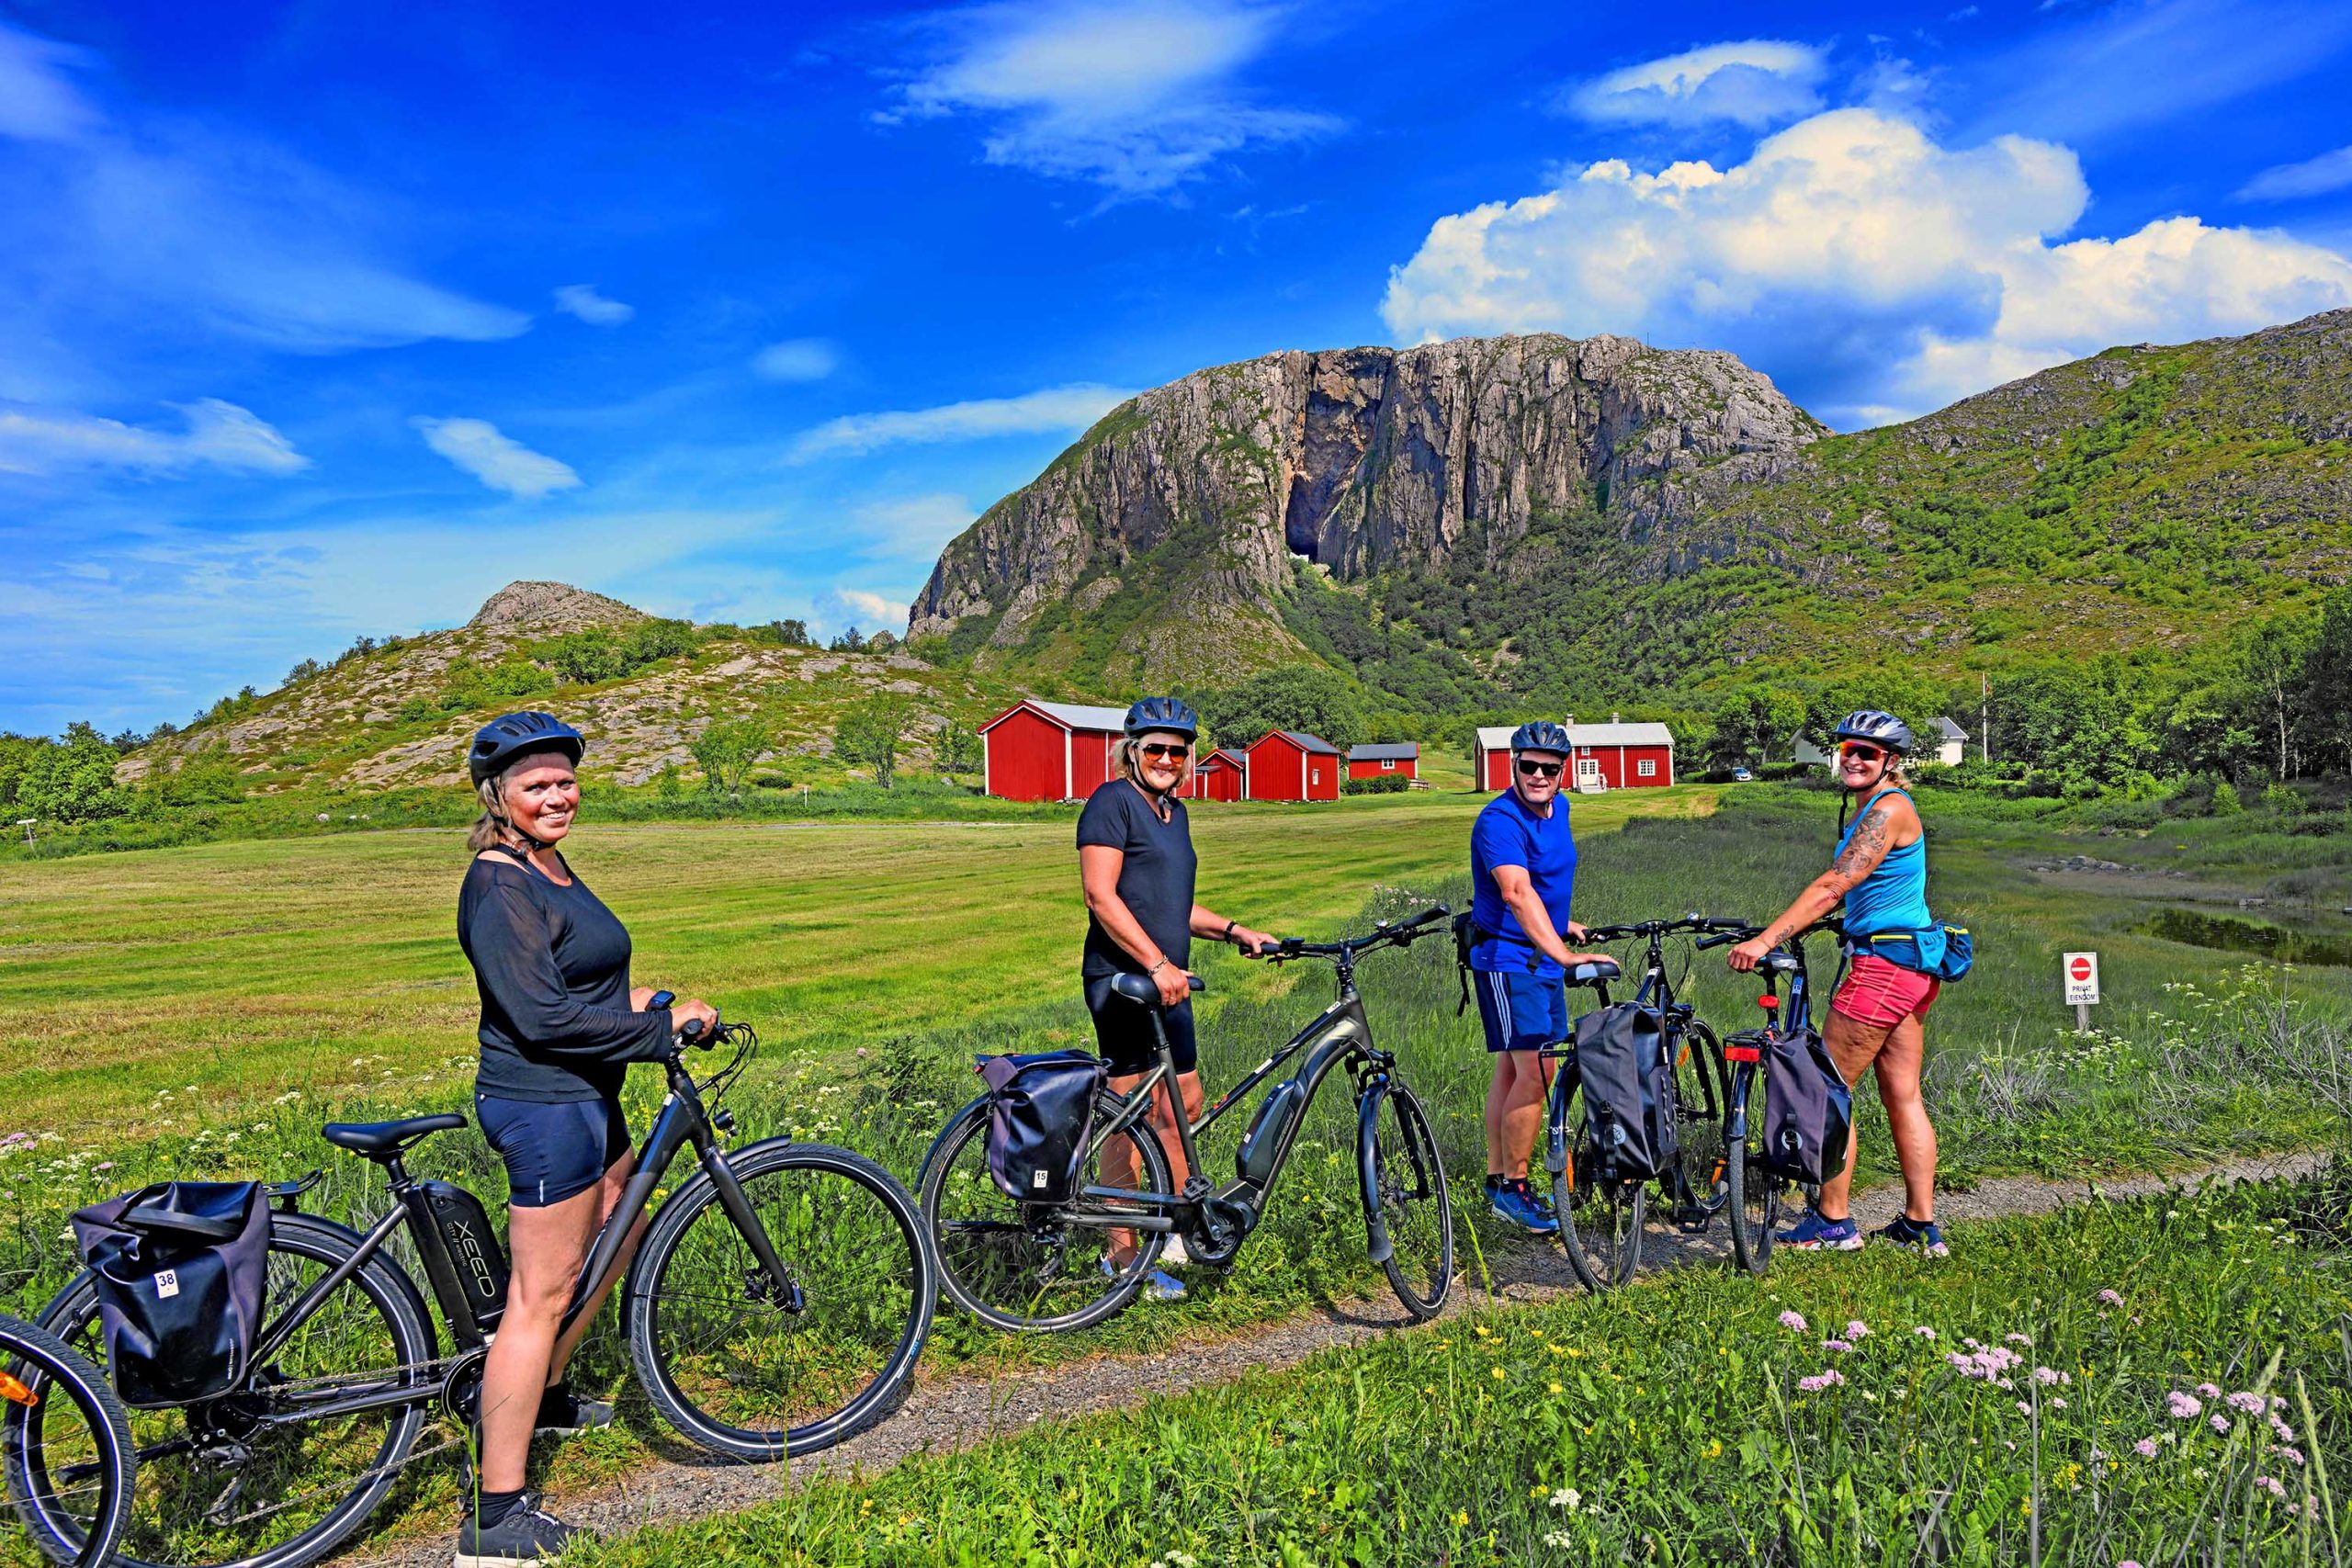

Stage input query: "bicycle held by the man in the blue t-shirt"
[{"left": 1541, "top": 915, "right": 1747, "bottom": 1293}]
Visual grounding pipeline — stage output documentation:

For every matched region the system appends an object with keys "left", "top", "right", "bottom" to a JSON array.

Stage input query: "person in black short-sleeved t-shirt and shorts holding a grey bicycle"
[{"left": 1077, "top": 696, "right": 1272, "bottom": 1300}]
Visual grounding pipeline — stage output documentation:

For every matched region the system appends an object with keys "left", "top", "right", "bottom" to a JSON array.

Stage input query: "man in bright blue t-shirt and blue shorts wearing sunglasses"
[{"left": 1470, "top": 719, "right": 1585, "bottom": 1236}]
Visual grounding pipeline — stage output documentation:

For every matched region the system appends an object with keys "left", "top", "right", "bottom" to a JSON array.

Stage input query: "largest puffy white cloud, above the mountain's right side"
[{"left": 1381, "top": 108, "right": 2352, "bottom": 423}]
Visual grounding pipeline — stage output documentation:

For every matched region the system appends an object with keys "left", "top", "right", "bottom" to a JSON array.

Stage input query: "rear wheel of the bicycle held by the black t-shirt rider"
[{"left": 920, "top": 1093, "right": 1171, "bottom": 1333}]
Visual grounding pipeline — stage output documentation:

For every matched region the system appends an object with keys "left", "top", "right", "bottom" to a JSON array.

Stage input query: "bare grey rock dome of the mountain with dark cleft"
[{"left": 908, "top": 333, "right": 1826, "bottom": 677}]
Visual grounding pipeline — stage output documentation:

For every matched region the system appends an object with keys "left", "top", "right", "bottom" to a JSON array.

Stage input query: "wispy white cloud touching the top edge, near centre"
[{"left": 875, "top": 0, "right": 1339, "bottom": 197}]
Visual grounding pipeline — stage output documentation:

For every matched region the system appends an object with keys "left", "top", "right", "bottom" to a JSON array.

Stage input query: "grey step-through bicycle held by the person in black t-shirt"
[{"left": 920, "top": 905, "right": 1453, "bottom": 1333}]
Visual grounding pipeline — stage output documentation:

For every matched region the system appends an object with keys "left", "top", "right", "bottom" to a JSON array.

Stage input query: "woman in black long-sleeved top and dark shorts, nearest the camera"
[{"left": 457, "top": 712, "right": 718, "bottom": 1568}]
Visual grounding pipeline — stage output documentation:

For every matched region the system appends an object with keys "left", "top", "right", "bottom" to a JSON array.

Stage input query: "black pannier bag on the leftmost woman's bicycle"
[{"left": 73, "top": 1182, "right": 270, "bottom": 1408}]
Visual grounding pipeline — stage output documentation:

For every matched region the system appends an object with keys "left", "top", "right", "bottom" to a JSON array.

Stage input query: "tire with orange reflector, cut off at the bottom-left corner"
[{"left": 0, "top": 1316, "right": 139, "bottom": 1568}]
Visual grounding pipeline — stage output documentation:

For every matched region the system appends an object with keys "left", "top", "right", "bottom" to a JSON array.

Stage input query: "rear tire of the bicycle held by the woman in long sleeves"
[{"left": 35, "top": 1213, "right": 440, "bottom": 1568}]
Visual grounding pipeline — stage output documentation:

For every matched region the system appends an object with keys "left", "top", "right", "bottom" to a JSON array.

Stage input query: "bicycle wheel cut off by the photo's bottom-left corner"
[{"left": 0, "top": 1319, "right": 139, "bottom": 1568}]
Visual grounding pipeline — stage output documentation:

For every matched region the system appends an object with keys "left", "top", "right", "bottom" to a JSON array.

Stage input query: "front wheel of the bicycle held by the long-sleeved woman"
[{"left": 623, "top": 1140, "right": 938, "bottom": 1462}]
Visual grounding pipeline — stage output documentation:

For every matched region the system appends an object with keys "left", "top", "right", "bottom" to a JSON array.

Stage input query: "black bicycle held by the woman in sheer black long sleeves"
[{"left": 26, "top": 997, "right": 938, "bottom": 1568}]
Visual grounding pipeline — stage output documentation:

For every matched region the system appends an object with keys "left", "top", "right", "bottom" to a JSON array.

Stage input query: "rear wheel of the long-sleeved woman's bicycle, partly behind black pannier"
[{"left": 30, "top": 1213, "right": 440, "bottom": 1568}]
